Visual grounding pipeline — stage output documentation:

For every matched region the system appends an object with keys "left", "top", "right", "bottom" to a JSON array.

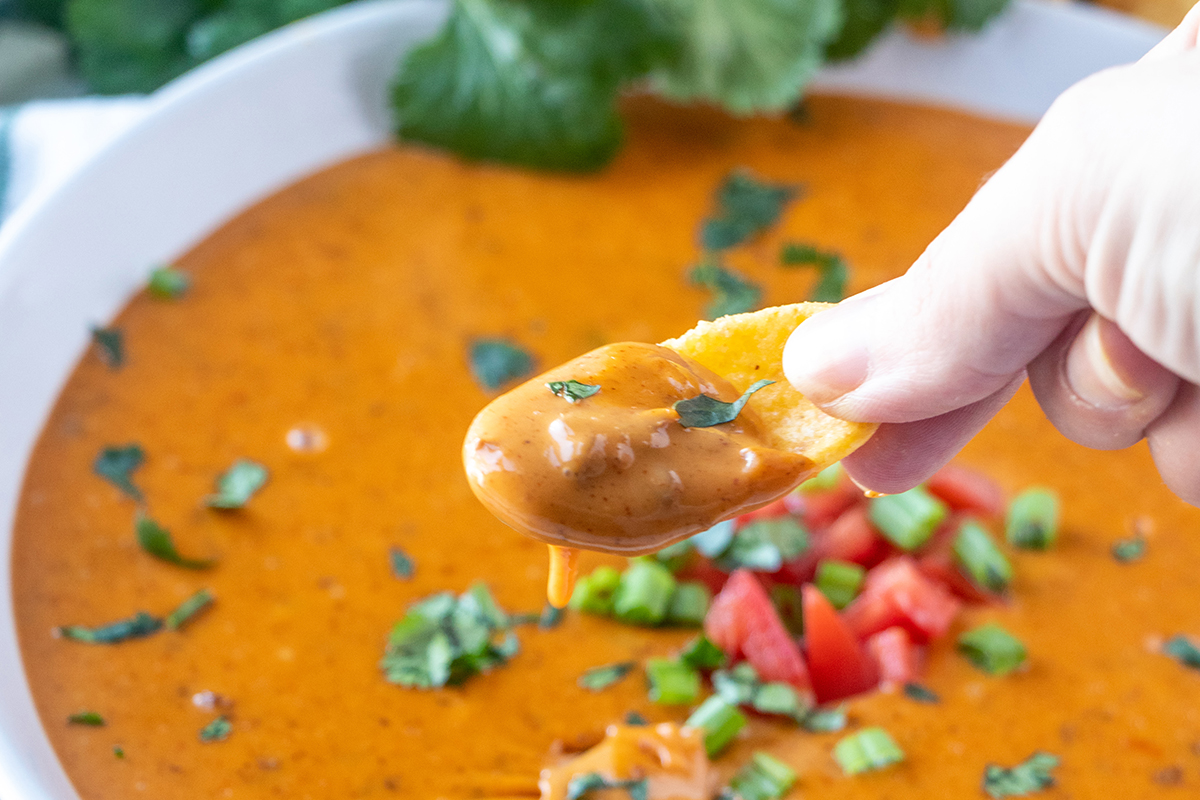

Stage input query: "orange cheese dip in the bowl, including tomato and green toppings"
[{"left": 12, "top": 97, "right": 1200, "bottom": 800}]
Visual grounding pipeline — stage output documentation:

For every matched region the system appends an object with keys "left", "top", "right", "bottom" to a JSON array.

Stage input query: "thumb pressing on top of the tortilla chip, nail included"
[{"left": 784, "top": 132, "right": 1087, "bottom": 422}]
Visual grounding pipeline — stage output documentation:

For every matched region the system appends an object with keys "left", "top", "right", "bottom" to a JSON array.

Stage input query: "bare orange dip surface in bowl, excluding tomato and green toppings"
[{"left": 12, "top": 97, "right": 1200, "bottom": 800}]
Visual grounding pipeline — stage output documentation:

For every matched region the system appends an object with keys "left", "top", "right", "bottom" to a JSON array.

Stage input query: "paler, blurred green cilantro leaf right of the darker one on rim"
[{"left": 652, "top": 0, "right": 841, "bottom": 115}]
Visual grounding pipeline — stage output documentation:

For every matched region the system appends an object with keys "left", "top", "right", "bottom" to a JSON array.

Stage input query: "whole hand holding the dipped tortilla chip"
[{"left": 784, "top": 5, "right": 1200, "bottom": 505}]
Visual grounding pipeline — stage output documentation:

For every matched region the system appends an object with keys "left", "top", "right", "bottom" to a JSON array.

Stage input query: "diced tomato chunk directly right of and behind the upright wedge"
[{"left": 842, "top": 555, "right": 961, "bottom": 644}]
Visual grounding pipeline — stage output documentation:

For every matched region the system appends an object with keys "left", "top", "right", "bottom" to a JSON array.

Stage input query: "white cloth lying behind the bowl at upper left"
[{"left": 0, "top": 96, "right": 150, "bottom": 224}]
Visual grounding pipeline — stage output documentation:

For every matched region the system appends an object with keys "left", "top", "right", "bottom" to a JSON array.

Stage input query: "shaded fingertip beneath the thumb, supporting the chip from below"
[{"left": 841, "top": 373, "right": 1025, "bottom": 494}]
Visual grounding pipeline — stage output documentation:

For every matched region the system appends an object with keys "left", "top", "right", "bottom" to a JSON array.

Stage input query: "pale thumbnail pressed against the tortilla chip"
[{"left": 784, "top": 302, "right": 869, "bottom": 405}]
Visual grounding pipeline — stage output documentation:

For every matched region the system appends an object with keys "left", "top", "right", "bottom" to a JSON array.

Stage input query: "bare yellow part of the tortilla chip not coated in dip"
[{"left": 662, "top": 302, "right": 878, "bottom": 469}]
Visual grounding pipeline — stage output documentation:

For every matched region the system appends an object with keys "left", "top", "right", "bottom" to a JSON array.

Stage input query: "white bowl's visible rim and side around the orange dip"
[{"left": 0, "top": 0, "right": 1163, "bottom": 800}]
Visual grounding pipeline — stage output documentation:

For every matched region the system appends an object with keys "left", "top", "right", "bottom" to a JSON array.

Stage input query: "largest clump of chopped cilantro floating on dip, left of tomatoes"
[{"left": 379, "top": 583, "right": 520, "bottom": 688}]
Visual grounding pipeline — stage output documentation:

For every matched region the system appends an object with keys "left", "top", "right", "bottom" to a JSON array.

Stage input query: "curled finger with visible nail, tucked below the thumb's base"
[{"left": 1030, "top": 313, "right": 1180, "bottom": 450}]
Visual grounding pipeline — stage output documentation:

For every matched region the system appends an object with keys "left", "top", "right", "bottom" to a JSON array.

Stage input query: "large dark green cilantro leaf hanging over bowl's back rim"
[{"left": 392, "top": 0, "right": 673, "bottom": 170}]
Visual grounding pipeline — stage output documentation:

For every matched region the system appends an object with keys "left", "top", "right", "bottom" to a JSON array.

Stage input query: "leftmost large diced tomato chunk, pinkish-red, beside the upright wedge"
[{"left": 704, "top": 570, "right": 810, "bottom": 691}]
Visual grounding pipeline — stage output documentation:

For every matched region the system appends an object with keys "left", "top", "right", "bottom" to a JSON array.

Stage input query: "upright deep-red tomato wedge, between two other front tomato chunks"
[{"left": 800, "top": 583, "right": 880, "bottom": 703}]
